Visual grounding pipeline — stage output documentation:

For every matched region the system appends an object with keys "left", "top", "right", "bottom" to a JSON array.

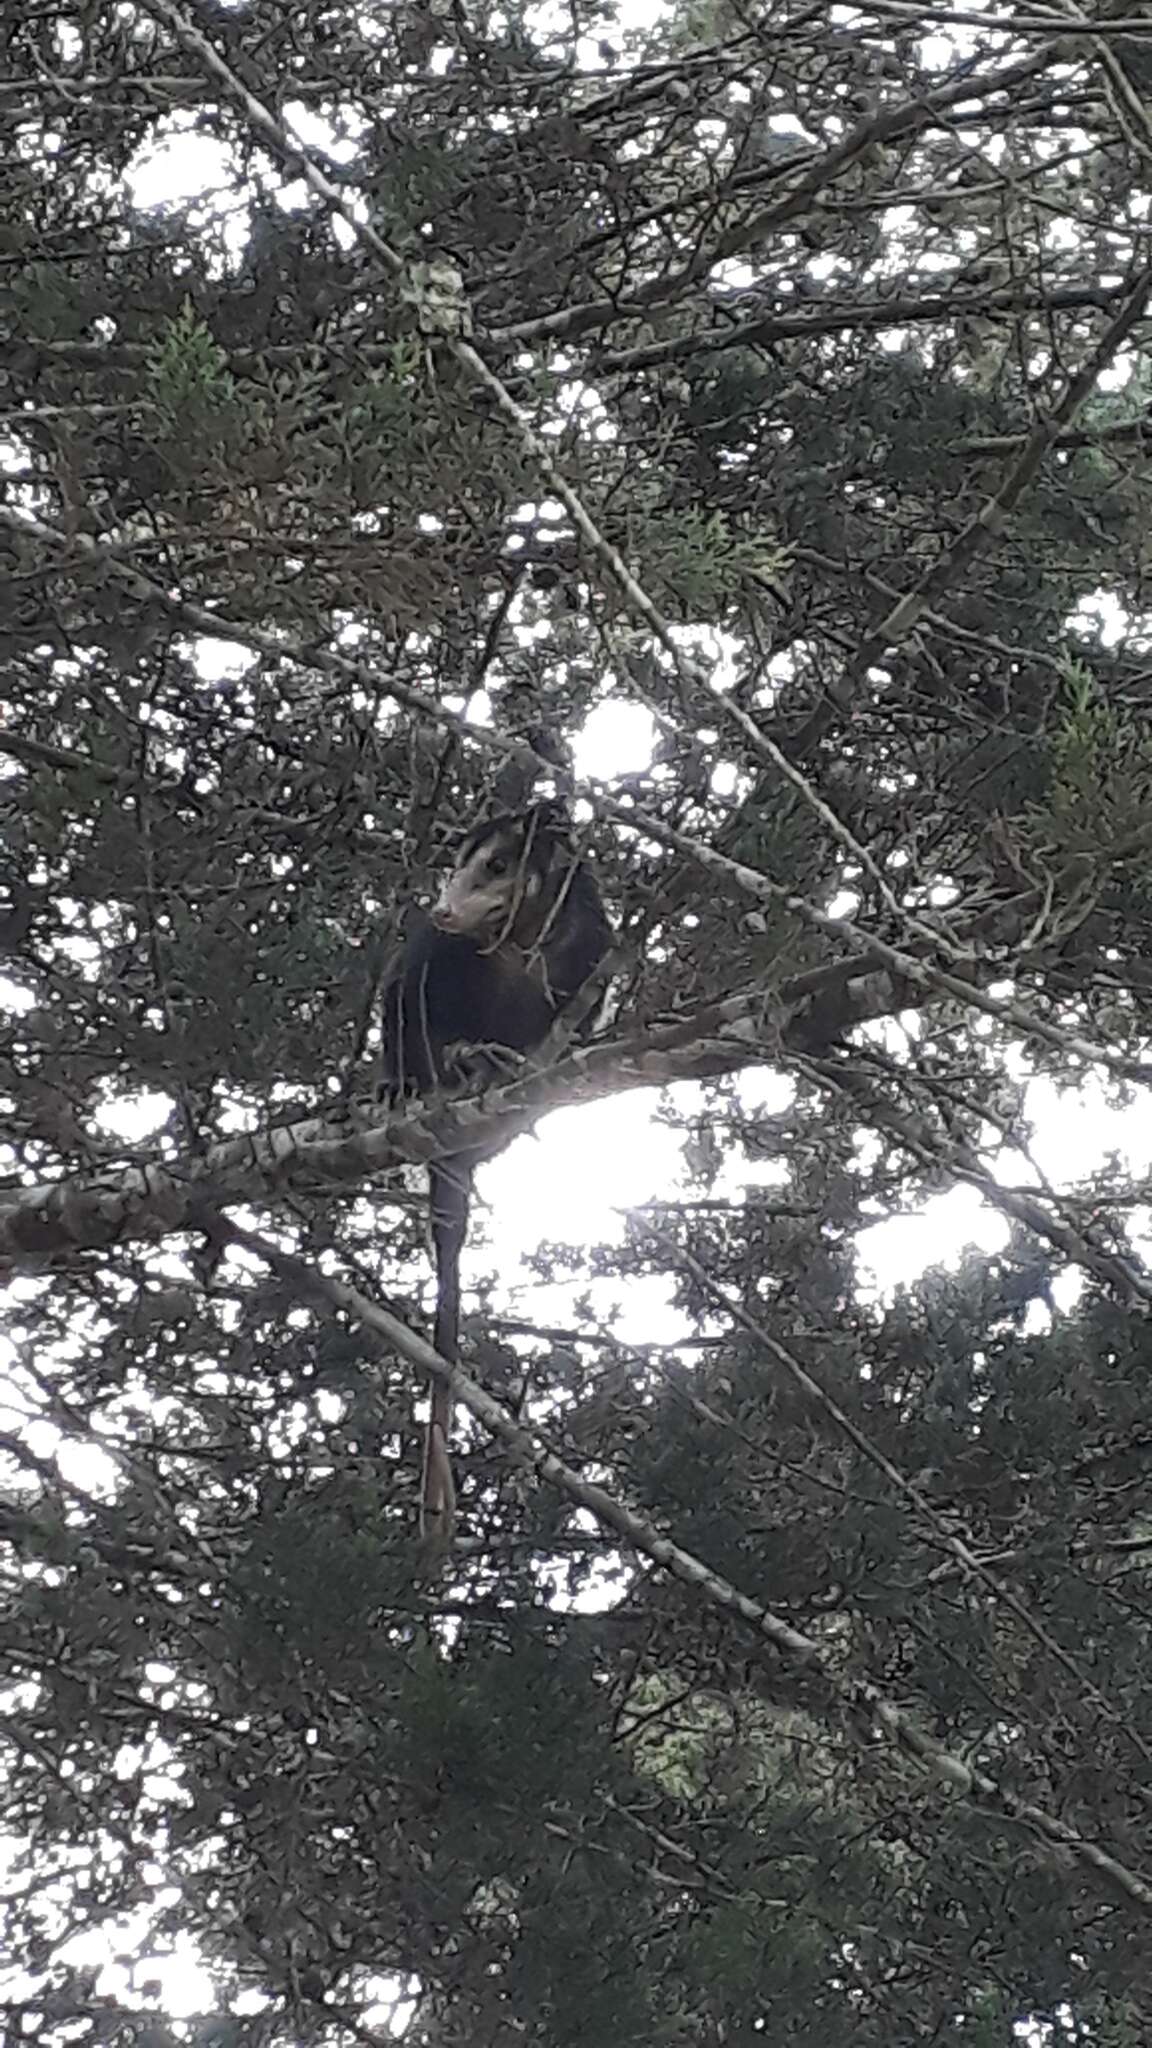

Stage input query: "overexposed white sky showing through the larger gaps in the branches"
[{"left": 0, "top": 0, "right": 1152, "bottom": 2032}]
